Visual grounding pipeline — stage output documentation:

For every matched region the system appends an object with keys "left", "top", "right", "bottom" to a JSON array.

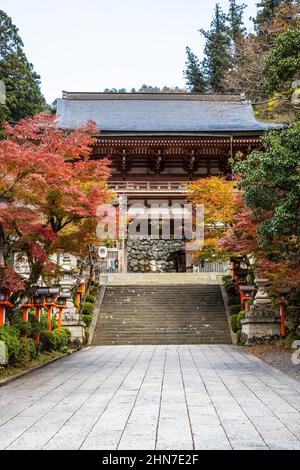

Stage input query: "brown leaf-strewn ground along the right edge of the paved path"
[{"left": 245, "top": 345, "right": 300, "bottom": 382}]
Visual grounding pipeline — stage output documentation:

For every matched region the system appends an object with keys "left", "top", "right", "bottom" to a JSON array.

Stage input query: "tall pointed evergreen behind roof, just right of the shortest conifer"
[{"left": 200, "top": 4, "right": 231, "bottom": 93}]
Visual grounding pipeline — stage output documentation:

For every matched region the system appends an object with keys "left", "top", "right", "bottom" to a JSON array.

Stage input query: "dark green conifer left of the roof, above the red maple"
[{"left": 0, "top": 10, "right": 46, "bottom": 121}]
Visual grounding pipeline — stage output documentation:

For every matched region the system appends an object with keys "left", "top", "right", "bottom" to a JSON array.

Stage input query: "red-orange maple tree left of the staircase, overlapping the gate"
[{"left": 0, "top": 113, "right": 112, "bottom": 298}]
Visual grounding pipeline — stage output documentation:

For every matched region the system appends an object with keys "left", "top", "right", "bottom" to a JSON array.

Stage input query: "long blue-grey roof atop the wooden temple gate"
[{"left": 57, "top": 92, "right": 277, "bottom": 133}]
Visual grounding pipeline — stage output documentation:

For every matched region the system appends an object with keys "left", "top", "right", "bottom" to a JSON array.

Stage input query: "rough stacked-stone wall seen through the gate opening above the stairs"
[{"left": 127, "top": 238, "right": 185, "bottom": 273}]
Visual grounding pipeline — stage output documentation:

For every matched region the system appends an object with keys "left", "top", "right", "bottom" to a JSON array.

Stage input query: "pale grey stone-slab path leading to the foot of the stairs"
[{"left": 0, "top": 346, "right": 300, "bottom": 450}]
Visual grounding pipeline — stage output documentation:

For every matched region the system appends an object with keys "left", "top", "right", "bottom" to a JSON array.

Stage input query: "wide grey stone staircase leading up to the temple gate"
[{"left": 92, "top": 274, "right": 232, "bottom": 345}]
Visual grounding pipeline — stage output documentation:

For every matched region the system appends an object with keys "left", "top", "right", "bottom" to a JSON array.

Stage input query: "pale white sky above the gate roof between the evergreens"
[{"left": 0, "top": 0, "right": 258, "bottom": 103}]
